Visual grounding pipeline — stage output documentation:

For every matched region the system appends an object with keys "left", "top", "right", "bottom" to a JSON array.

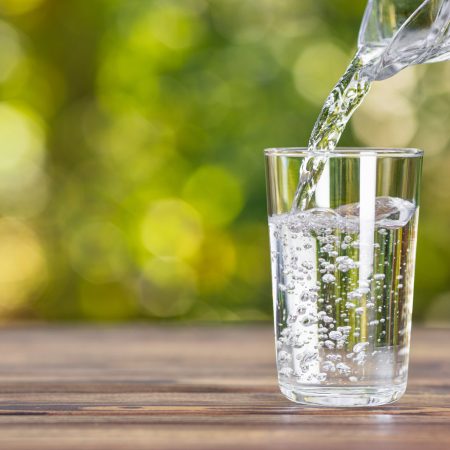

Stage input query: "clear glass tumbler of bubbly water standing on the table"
[{"left": 265, "top": 148, "right": 423, "bottom": 407}]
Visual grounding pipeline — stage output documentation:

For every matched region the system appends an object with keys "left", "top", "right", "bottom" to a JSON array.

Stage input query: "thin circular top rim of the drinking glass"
[{"left": 264, "top": 147, "right": 423, "bottom": 158}]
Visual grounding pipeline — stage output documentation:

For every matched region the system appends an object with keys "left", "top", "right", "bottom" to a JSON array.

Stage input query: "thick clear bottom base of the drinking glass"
[{"left": 280, "top": 383, "right": 406, "bottom": 408}]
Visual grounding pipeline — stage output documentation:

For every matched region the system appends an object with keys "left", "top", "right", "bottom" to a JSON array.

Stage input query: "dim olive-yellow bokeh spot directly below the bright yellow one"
[{"left": 141, "top": 258, "right": 196, "bottom": 318}]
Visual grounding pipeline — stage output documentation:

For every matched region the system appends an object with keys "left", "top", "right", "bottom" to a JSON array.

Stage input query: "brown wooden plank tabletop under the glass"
[{"left": 0, "top": 325, "right": 450, "bottom": 450}]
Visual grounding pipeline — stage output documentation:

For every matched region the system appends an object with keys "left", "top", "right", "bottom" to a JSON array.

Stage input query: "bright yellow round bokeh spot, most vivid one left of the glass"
[{"left": 141, "top": 199, "right": 203, "bottom": 258}]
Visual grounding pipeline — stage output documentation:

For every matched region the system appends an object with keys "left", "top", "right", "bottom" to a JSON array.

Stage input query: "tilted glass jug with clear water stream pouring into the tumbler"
[{"left": 291, "top": 0, "right": 450, "bottom": 214}]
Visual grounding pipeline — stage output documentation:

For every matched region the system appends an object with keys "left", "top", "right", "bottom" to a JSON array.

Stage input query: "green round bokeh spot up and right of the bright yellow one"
[{"left": 183, "top": 166, "right": 243, "bottom": 225}]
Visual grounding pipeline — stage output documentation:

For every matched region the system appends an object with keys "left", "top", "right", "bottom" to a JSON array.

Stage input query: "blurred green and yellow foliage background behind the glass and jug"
[{"left": 0, "top": 0, "right": 450, "bottom": 322}]
